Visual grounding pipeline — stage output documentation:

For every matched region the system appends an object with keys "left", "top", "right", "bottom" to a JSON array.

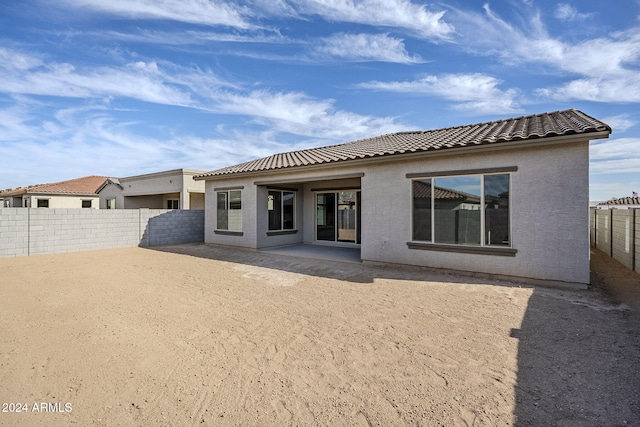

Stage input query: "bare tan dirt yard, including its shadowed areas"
[{"left": 0, "top": 245, "right": 640, "bottom": 426}]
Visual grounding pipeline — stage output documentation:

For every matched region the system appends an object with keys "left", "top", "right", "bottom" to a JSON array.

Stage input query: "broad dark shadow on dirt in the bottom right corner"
[{"left": 512, "top": 249, "right": 640, "bottom": 427}]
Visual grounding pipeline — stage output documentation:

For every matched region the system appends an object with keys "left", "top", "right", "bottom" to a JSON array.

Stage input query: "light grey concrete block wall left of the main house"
[{"left": 0, "top": 208, "right": 204, "bottom": 258}]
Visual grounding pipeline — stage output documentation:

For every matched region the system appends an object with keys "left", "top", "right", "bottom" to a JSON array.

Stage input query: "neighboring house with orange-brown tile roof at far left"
[{"left": 0, "top": 176, "right": 107, "bottom": 209}]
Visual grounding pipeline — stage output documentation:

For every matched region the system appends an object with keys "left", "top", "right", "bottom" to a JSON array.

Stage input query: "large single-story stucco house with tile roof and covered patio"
[{"left": 196, "top": 110, "right": 611, "bottom": 285}]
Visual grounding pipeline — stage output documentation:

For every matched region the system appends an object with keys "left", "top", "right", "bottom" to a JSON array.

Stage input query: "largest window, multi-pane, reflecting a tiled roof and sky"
[{"left": 412, "top": 174, "right": 511, "bottom": 247}]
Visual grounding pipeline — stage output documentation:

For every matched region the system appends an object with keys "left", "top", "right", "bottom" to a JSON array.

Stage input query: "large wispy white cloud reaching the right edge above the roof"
[{"left": 452, "top": 5, "right": 640, "bottom": 102}]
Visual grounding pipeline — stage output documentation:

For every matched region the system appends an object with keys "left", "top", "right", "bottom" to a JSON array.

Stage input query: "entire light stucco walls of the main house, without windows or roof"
[{"left": 205, "top": 141, "right": 589, "bottom": 284}]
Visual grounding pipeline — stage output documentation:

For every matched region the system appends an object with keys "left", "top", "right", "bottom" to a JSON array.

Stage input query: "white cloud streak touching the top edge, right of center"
[{"left": 291, "top": 0, "right": 454, "bottom": 39}]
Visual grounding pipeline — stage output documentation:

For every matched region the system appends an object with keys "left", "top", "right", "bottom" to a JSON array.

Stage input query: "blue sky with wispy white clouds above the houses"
[{"left": 0, "top": 0, "right": 640, "bottom": 200}]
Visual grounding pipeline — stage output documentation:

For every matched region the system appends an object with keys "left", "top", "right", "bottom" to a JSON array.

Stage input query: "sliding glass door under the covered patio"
[{"left": 316, "top": 190, "right": 360, "bottom": 244}]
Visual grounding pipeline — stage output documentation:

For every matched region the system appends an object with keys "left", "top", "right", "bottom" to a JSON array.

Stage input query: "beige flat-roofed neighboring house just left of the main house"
[{"left": 97, "top": 169, "right": 204, "bottom": 209}]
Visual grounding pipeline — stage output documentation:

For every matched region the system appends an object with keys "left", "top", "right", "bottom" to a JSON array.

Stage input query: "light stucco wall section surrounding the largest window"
[{"left": 361, "top": 142, "right": 589, "bottom": 284}]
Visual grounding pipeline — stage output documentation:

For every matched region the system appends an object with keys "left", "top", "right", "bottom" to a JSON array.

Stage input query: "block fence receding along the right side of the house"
[{"left": 589, "top": 209, "right": 640, "bottom": 273}]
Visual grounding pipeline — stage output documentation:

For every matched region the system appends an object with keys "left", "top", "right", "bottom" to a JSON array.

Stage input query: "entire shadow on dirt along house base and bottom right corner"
[{"left": 149, "top": 244, "right": 640, "bottom": 427}]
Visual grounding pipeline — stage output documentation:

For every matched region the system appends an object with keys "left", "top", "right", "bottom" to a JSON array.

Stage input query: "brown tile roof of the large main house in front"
[{"left": 195, "top": 110, "right": 611, "bottom": 179}]
